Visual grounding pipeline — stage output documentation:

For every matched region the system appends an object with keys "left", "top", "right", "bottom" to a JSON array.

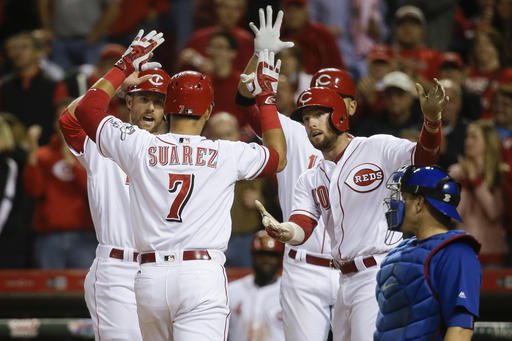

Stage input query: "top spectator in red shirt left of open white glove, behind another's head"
[{"left": 176, "top": 0, "right": 253, "bottom": 72}]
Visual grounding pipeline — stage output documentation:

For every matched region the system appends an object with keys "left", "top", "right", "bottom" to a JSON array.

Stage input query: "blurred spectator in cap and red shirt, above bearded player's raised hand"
[{"left": 388, "top": 5, "right": 440, "bottom": 85}]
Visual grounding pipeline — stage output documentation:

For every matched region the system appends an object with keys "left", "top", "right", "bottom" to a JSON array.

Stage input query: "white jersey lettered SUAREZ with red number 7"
[{"left": 96, "top": 116, "right": 269, "bottom": 252}]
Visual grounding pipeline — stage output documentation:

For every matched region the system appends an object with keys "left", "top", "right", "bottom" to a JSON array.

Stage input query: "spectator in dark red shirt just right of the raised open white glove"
[{"left": 281, "top": 0, "right": 345, "bottom": 75}]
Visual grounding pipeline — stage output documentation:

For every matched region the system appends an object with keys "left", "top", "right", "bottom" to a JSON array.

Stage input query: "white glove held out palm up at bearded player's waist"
[{"left": 254, "top": 200, "right": 305, "bottom": 245}]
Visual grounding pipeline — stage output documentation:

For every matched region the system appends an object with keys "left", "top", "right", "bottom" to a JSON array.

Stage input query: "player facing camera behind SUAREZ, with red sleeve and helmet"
[{"left": 59, "top": 70, "right": 170, "bottom": 340}]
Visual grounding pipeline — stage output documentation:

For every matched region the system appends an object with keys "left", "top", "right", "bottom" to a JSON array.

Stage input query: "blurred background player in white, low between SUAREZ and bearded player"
[{"left": 228, "top": 230, "right": 285, "bottom": 341}]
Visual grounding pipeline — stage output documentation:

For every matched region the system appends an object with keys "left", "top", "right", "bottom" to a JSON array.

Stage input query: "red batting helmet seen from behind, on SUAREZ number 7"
[{"left": 165, "top": 71, "right": 213, "bottom": 117}]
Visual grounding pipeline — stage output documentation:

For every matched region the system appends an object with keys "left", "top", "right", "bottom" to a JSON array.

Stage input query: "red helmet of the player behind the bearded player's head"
[{"left": 310, "top": 68, "right": 356, "bottom": 98}]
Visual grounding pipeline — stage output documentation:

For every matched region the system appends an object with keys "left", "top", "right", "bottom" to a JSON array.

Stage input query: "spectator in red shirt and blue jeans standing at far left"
[{"left": 23, "top": 100, "right": 97, "bottom": 269}]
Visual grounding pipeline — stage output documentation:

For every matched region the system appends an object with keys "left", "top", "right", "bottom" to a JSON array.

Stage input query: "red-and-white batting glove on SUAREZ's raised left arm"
[{"left": 115, "top": 30, "right": 165, "bottom": 76}]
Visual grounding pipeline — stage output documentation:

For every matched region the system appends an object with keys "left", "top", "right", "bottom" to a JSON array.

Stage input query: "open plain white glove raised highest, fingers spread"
[{"left": 249, "top": 5, "right": 295, "bottom": 53}]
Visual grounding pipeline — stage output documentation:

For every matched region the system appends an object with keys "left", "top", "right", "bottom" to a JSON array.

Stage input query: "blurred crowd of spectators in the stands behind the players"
[{"left": 0, "top": 0, "right": 512, "bottom": 269}]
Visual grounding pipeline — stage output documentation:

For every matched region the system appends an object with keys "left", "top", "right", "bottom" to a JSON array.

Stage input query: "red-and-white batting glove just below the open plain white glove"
[{"left": 240, "top": 50, "right": 281, "bottom": 105}]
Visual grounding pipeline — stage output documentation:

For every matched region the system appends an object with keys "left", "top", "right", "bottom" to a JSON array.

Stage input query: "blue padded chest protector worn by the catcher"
[{"left": 374, "top": 230, "right": 476, "bottom": 341}]
